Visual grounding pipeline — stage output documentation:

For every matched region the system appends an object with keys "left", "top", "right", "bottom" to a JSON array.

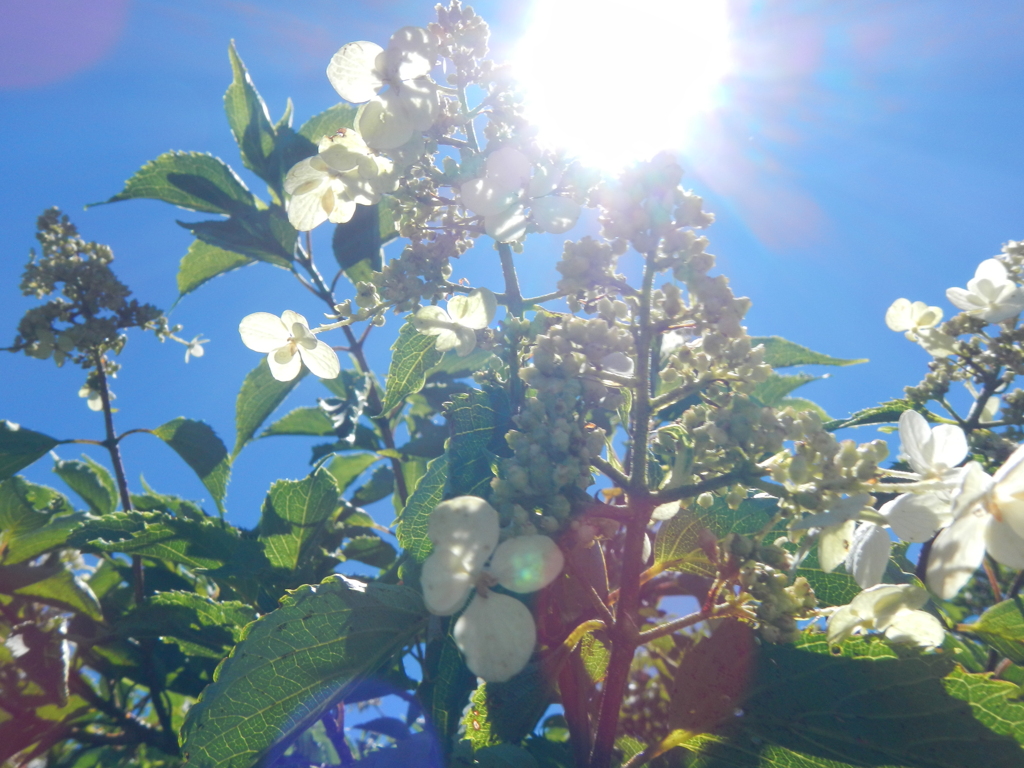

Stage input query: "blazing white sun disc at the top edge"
[{"left": 514, "top": 0, "right": 732, "bottom": 171}]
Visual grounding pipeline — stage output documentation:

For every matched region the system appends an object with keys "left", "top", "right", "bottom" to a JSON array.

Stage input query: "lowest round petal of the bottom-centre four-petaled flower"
[{"left": 452, "top": 592, "right": 537, "bottom": 683}]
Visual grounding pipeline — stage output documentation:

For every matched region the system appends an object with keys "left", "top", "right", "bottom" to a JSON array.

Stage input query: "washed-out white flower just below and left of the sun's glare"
[{"left": 459, "top": 146, "right": 580, "bottom": 243}]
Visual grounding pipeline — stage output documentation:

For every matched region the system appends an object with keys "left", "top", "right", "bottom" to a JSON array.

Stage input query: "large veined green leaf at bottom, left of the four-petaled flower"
[{"left": 181, "top": 575, "right": 427, "bottom": 768}]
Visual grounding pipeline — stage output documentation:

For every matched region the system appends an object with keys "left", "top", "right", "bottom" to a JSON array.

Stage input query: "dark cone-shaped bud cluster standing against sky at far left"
[{"left": 9, "top": 208, "right": 164, "bottom": 368}]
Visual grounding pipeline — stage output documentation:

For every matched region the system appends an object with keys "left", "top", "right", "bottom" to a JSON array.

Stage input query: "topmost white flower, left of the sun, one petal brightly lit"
[{"left": 327, "top": 27, "right": 438, "bottom": 150}]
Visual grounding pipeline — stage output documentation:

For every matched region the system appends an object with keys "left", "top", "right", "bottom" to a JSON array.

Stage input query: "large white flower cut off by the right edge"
[{"left": 926, "top": 445, "right": 1024, "bottom": 600}]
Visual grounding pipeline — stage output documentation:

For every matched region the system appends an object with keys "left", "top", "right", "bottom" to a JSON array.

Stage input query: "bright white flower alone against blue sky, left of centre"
[{"left": 239, "top": 309, "right": 341, "bottom": 381}]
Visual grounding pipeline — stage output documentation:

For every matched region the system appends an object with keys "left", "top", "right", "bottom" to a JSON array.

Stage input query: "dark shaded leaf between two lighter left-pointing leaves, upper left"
[{"left": 177, "top": 205, "right": 298, "bottom": 269}]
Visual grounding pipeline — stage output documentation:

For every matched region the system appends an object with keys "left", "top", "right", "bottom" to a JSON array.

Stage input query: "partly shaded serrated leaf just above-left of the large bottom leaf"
[{"left": 115, "top": 591, "right": 256, "bottom": 659}]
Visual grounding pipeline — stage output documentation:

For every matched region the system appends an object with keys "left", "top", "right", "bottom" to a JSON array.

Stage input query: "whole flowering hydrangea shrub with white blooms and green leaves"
[{"left": 6, "top": 0, "right": 1024, "bottom": 768}]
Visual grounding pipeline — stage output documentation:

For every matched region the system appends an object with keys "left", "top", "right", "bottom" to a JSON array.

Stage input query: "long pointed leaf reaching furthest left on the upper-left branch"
[{"left": 92, "top": 152, "right": 256, "bottom": 214}]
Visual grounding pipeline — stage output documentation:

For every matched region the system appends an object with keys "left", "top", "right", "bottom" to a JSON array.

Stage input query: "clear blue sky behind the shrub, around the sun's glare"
[{"left": 0, "top": 0, "right": 1024, "bottom": 525}]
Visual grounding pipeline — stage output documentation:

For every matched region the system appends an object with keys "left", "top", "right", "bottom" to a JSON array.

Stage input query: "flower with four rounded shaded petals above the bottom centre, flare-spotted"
[{"left": 420, "top": 496, "right": 565, "bottom": 683}]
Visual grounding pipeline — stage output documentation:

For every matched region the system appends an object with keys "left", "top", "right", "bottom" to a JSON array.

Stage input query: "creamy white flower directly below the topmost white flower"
[{"left": 285, "top": 129, "right": 393, "bottom": 231}]
